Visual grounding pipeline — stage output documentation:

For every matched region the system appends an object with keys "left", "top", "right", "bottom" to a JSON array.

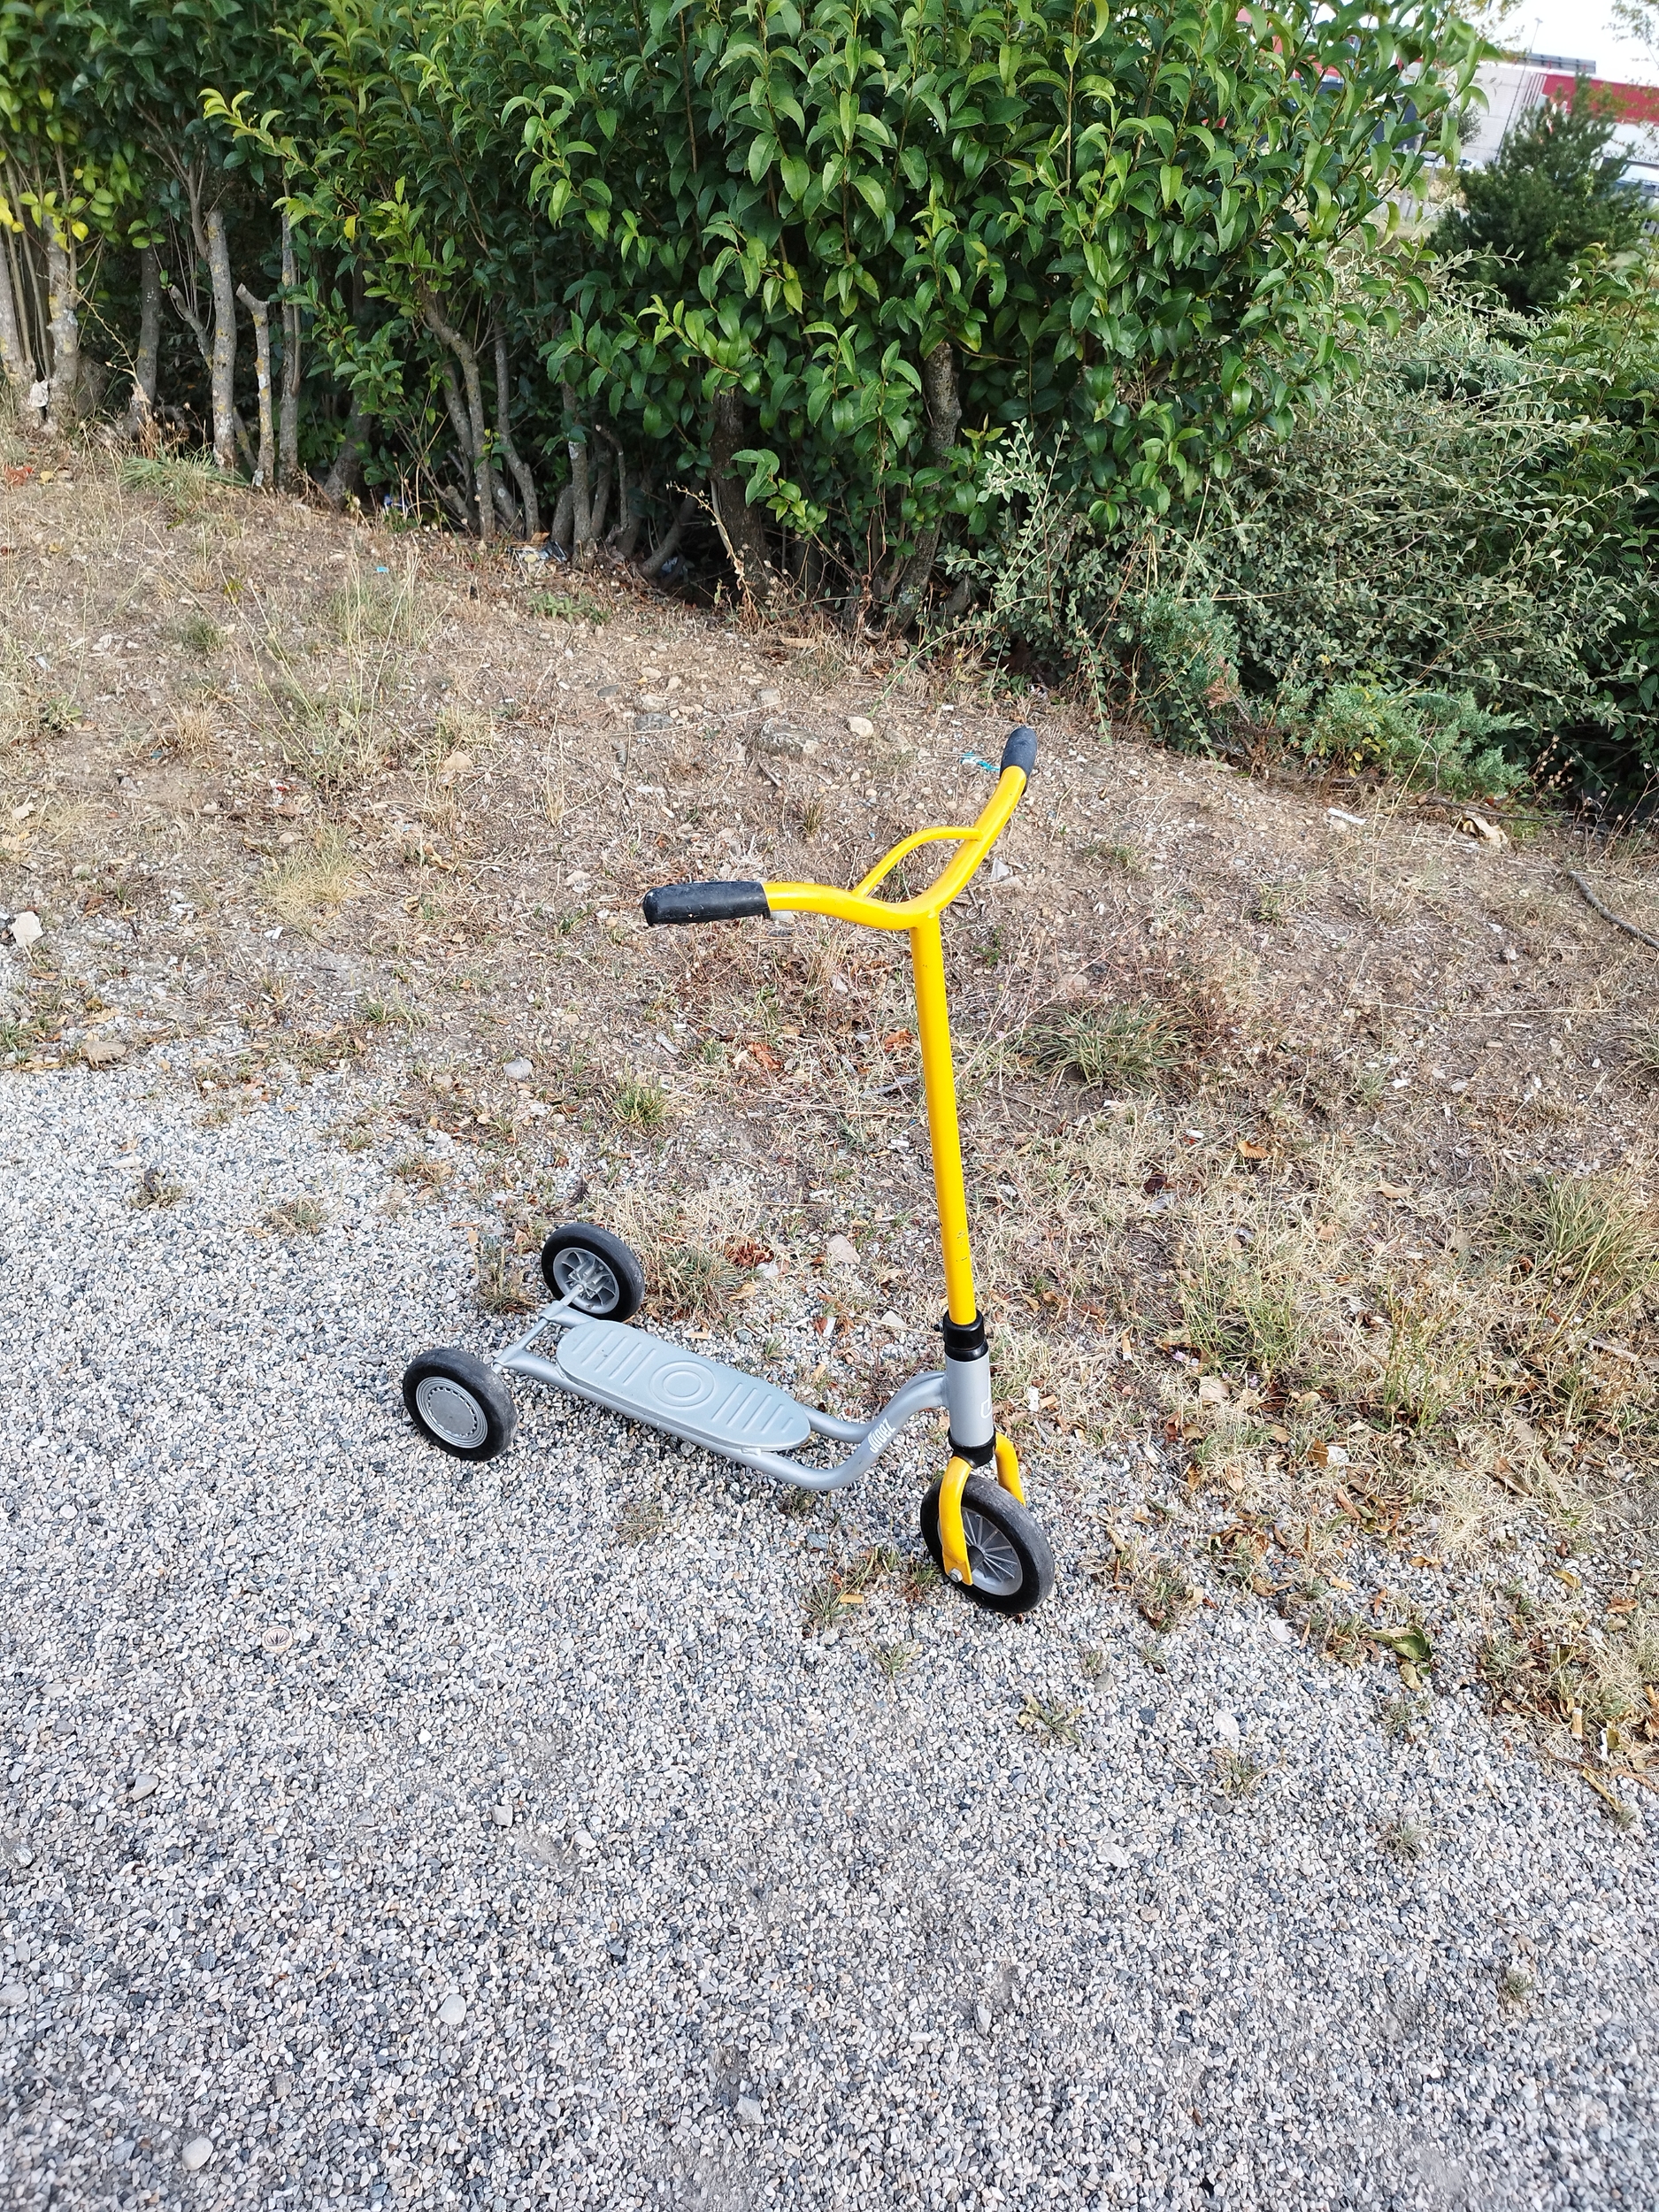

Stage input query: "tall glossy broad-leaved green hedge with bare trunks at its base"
[{"left": 0, "top": 0, "right": 1473, "bottom": 622}]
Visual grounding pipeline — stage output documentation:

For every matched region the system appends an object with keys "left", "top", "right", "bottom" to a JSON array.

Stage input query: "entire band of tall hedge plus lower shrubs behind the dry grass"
[{"left": 16, "top": 0, "right": 1659, "bottom": 810}]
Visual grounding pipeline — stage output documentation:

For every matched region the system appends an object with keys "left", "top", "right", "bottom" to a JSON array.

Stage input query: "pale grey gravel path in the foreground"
[{"left": 0, "top": 1066, "right": 1659, "bottom": 2212}]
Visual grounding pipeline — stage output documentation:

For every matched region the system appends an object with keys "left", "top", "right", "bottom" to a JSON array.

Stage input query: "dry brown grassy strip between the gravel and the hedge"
[{"left": 0, "top": 431, "right": 1659, "bottom": 1778}]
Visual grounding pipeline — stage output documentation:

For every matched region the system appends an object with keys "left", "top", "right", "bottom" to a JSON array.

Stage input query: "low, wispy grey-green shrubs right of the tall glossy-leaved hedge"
[{"left": 973, "top": 261, "right": 1659, "bottom": 795}]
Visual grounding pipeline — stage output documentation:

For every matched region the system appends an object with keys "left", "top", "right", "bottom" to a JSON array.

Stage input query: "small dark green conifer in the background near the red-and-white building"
[{"left": 1433, "top": 82, "right": 1644, "bottom": 310}]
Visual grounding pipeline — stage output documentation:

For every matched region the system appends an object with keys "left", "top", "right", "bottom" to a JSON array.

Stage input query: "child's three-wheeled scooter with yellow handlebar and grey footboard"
[{"left": 403, "top": 728, "right": 1056, "bottom": 1613}]
